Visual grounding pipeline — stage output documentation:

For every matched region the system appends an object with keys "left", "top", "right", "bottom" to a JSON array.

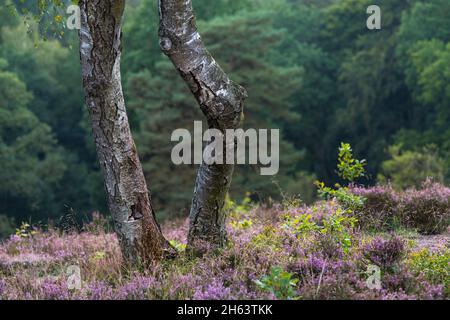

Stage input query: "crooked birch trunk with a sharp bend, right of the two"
[{"left": 159, "top": 0, "right": 247, "bottom": 253}]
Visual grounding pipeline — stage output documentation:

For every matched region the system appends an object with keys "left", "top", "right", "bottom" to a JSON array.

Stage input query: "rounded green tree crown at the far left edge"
[{"left": 0, "top": 60, "right": 67, "bottom": 219}]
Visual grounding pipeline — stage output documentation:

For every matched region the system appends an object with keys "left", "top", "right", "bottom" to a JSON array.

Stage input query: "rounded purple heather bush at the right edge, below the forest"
[{"left": 399, "top": 180, "right": 450, "bottom": 234}]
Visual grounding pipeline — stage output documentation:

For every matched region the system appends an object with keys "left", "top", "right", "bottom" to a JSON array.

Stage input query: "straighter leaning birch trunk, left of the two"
[{"left": 79, "top": 0, "right": 174, "bottom": 265}]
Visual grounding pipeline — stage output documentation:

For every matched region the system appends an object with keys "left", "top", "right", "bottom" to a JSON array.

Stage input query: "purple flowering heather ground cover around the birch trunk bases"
[{"left": 0, "top": 198, "right": 450, "bottom": 300}]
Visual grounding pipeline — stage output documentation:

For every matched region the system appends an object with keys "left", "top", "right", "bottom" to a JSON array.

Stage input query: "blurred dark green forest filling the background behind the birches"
[{"left": 0, "top": 0, "right": 450, "bottom": 237}]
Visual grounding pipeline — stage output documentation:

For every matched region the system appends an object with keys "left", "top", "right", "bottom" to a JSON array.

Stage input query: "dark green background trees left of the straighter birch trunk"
[{"left": 0, "top": 8, "right": 104, "bottom": 223}]
